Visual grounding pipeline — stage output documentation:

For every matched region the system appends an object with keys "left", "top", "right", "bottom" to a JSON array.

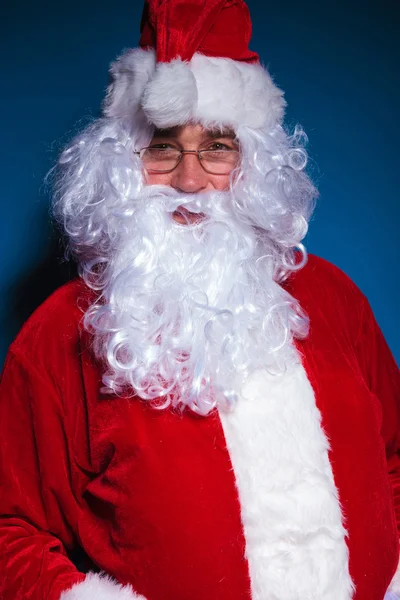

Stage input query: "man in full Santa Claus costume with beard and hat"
[{"left": 0, "top": 0, "right": 400, "bottom": 600}]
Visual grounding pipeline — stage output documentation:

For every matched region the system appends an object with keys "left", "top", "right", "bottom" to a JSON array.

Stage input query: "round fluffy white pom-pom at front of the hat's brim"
[{"left": 141, "top": 59, "right": 198, "bottom": 127}]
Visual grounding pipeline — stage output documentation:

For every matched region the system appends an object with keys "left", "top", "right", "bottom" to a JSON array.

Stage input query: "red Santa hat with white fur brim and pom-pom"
[{"left": 104, "top": 0, "right": 286, "bottom": 129}]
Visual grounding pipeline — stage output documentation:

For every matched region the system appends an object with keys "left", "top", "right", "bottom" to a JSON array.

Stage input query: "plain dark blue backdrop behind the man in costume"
[{"left": 0, "top": 0, "right": 400, "bottom": 363}]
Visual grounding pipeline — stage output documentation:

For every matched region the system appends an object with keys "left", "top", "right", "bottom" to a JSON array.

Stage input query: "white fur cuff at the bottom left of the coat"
[{"left": 60, "top": 573, "right": 146, "bottom": 600}]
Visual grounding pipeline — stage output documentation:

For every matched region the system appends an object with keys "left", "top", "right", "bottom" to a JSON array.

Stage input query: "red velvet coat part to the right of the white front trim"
[{"left": 288, "top": 257, "right": 400, "bottom": 600}]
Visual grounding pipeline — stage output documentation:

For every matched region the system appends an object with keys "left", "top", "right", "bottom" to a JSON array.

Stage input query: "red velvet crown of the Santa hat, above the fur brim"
[{"left": 139, "top": 0, "right": 259, "bottom": 62}]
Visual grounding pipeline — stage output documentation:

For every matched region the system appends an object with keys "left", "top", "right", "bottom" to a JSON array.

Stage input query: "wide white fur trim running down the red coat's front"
[{"left": 220, "top": 364, "right": 354, "bottom": 600}]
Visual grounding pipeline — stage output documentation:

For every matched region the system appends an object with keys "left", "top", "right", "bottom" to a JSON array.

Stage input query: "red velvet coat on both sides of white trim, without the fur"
[{"left": 0, "top": 257, "right": 400, "bottom": 600}]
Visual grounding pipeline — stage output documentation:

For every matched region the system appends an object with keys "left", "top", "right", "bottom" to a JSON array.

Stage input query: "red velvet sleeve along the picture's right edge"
[{"left": 357, "top": 298, "right": 400, "bottom": 532}]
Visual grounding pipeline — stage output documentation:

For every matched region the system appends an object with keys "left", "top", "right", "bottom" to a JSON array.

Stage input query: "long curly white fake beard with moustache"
[{"left": 85, "top": 186, "right": 308, "bottom": 414}]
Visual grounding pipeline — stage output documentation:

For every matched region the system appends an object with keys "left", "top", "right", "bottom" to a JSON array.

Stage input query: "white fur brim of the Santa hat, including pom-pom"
[{"left": 104, "top": 48, "right": 286, "bottom": 129}]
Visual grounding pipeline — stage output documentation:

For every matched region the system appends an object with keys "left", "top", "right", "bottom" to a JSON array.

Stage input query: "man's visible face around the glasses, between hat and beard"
[{"left": 146, "top": 125, "right": 239, "bottom": 224}]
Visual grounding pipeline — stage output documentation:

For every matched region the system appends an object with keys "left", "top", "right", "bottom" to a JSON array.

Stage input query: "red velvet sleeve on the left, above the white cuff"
[{"left": 0, "top": 350, "right": 84, "bottom": 600}]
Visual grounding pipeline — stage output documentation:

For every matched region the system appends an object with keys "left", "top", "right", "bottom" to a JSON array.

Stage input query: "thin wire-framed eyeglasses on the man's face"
[{"left": 134, "top": 146, "right": 240, "bottom": 175}]
